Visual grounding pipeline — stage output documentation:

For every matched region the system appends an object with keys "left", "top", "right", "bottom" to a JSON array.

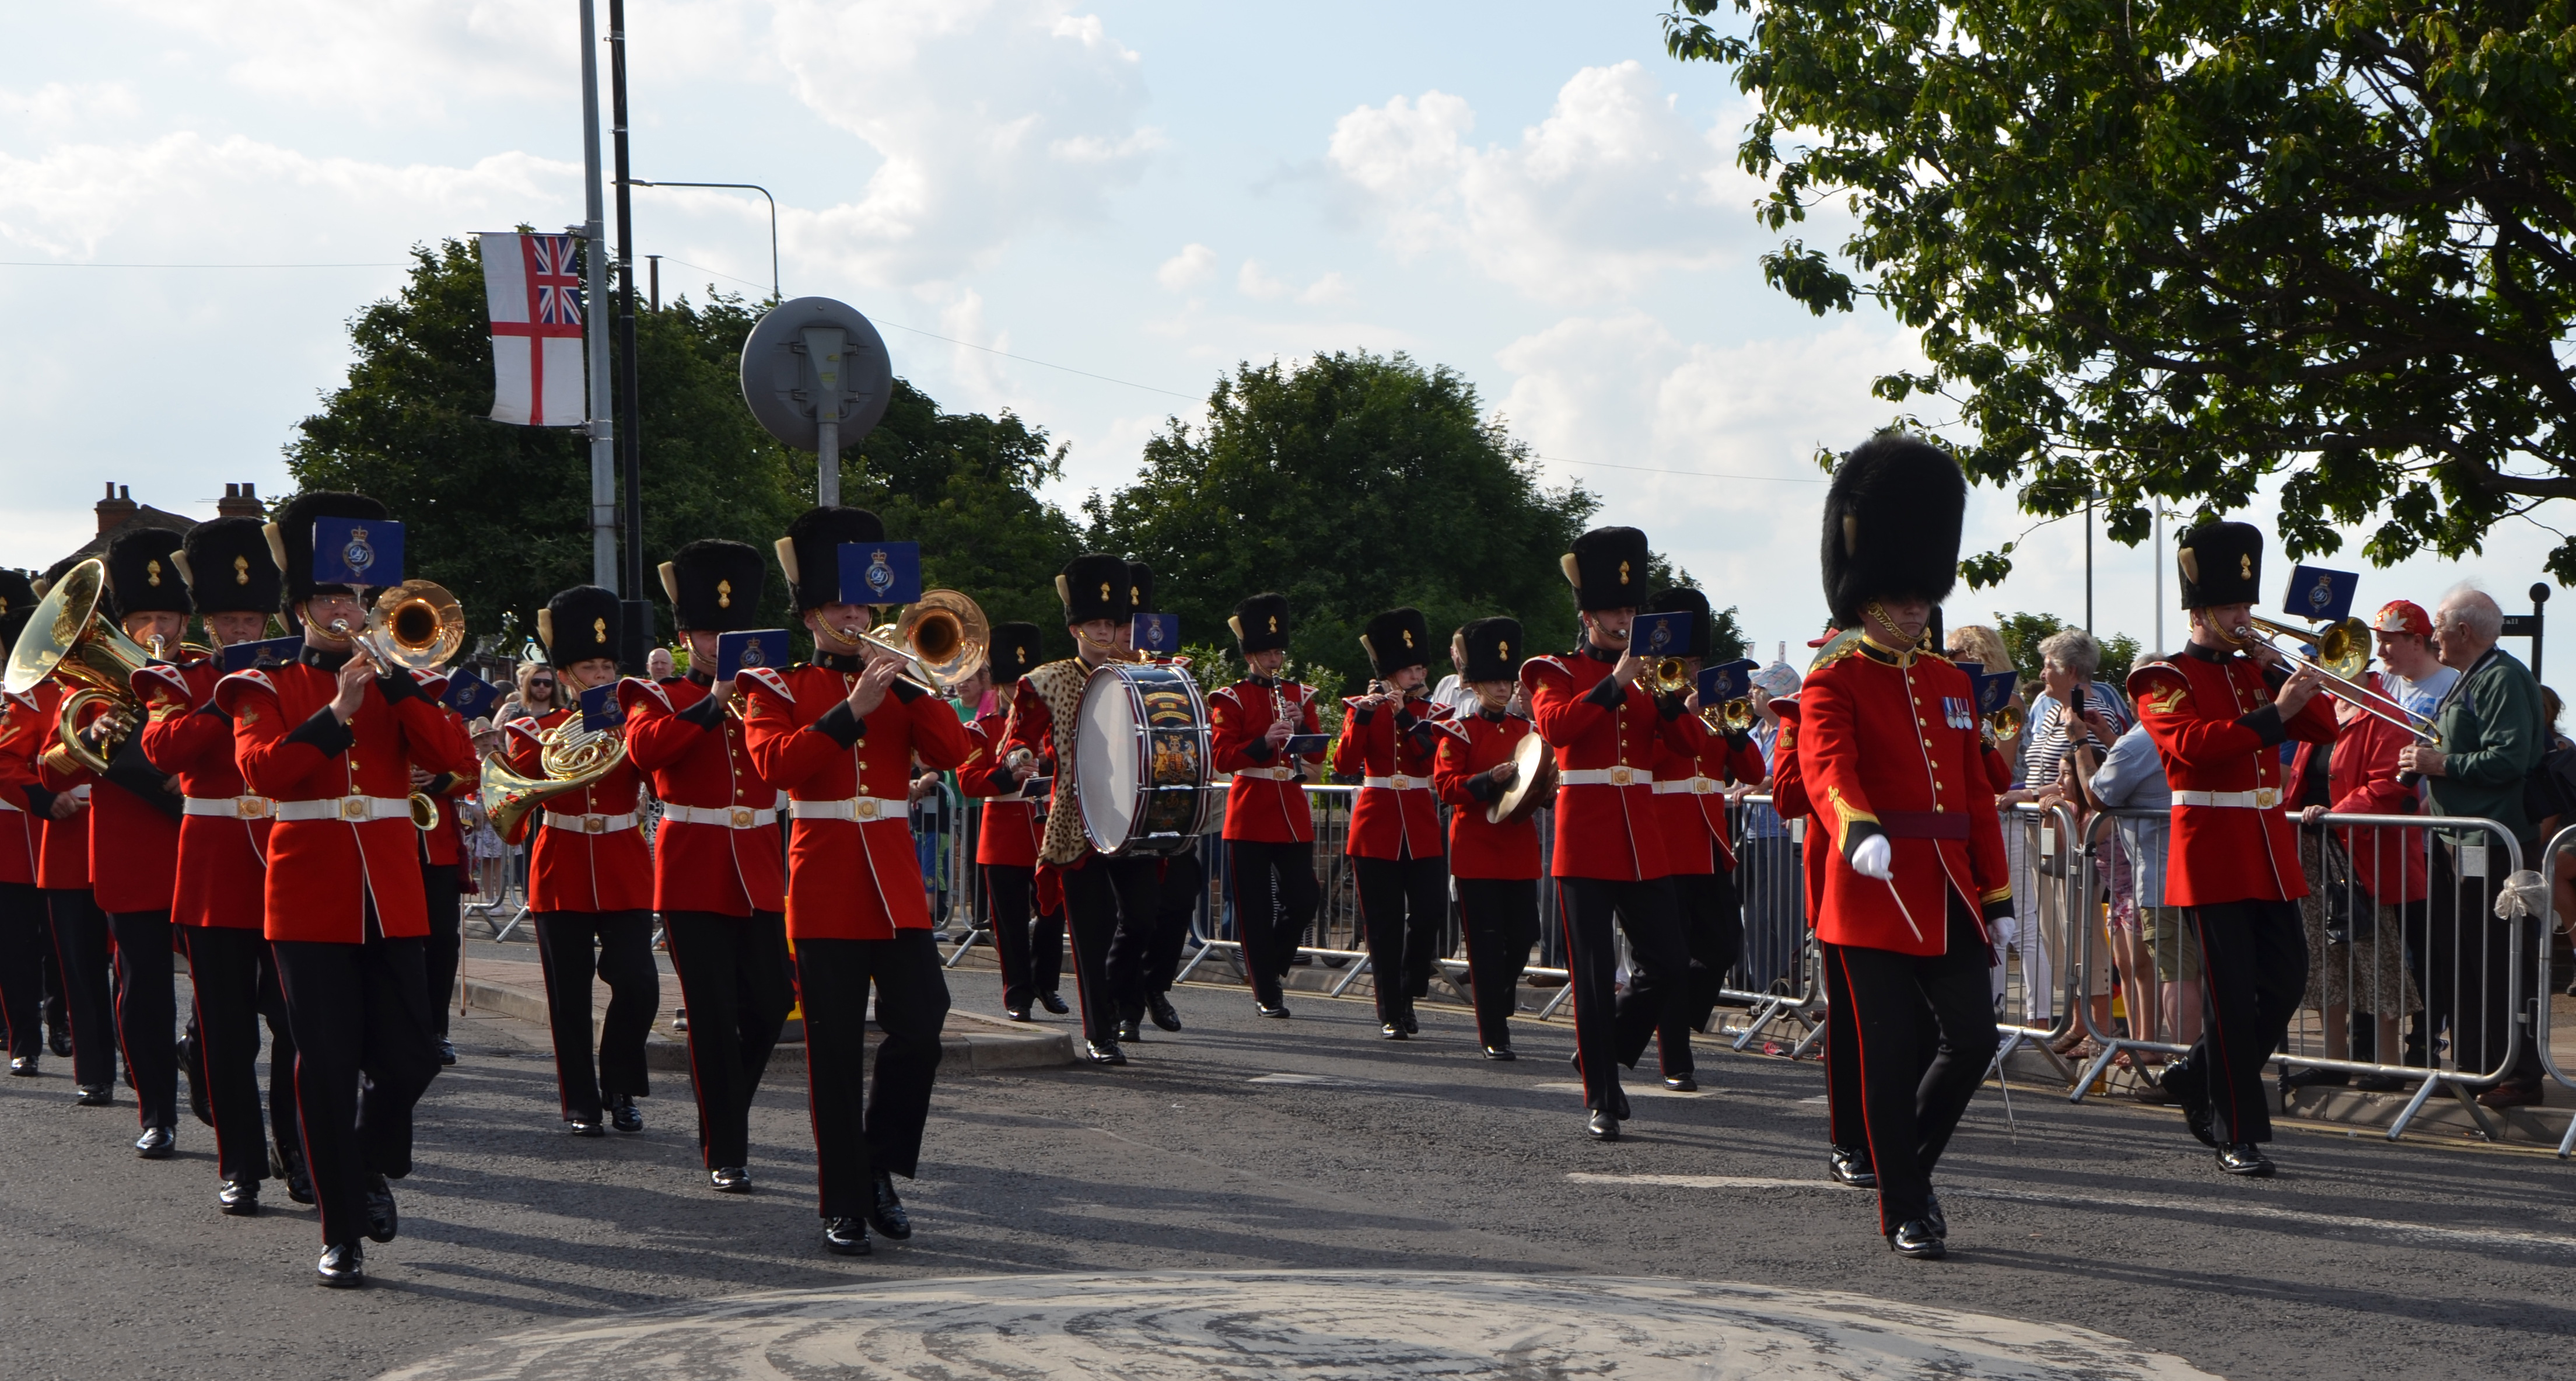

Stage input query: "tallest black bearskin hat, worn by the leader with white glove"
[{"left": 1824, "top": 430, "right": 1968, "bottom": 629}]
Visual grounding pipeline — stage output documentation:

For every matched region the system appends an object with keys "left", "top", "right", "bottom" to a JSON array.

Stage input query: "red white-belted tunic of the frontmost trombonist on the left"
[{"left": 214, "top": 662, "right": 474, "bottom": 946}]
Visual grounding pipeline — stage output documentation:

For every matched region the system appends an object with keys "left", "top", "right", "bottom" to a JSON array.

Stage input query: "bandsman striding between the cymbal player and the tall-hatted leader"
[{"left": 1520, "top": 528, "right": 1698, "bottom": 1141}]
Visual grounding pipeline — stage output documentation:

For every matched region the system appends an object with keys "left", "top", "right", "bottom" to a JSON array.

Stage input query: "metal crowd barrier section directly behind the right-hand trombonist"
[{"left": 2068, "top": 809, "right": 2524, "bottom": 1138}]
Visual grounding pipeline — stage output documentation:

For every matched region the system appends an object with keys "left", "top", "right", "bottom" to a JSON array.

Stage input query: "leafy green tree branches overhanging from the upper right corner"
[{"left": 1664, "top": 0, "right": 2576, "bottom": 582}]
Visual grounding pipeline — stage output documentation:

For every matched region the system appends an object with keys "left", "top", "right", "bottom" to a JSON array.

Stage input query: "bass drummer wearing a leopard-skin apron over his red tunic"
[{"left": 1005, "top": 554, "right": 1162, "bottom": 1064}]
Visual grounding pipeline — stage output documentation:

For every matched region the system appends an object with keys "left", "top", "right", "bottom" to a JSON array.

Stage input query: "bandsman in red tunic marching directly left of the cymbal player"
[{"left": 1332, "top": 608, "right": 1448, "bottom": 1041}]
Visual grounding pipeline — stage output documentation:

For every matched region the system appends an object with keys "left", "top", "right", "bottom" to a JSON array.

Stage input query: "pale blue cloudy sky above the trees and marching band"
[{"left": 0, "top": 0, "right": 2576, "bottom": 690}]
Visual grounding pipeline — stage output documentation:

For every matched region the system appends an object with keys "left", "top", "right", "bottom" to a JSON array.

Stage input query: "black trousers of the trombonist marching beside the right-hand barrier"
[{"left": 2190, "top": 902, "right": 2308, "bottom": 1146}]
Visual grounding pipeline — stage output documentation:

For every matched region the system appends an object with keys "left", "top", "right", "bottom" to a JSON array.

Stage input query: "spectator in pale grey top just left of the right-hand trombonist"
[{"left": 2084, "top": 705, "right": 2200, "bottom": 1064}]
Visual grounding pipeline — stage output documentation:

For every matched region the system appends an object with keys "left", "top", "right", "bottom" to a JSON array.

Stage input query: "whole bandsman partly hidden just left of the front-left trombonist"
[{"left": 134, "top": 518, "right": 314, "bottom": 1219}]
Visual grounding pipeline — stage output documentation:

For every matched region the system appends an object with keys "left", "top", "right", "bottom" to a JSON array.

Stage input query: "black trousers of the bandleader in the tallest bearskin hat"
[{"left": 1824, "top": 891, "right": 1999, "bottom": 1232}]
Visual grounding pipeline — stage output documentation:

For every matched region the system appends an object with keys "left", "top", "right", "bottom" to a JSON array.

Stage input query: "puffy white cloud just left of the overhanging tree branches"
[{"left": 1326, "top": 62, "right": 1759, "bottom": 304}]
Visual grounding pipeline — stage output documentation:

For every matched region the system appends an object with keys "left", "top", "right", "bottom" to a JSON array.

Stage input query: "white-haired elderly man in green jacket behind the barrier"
[{"left": 2398, "top": 585, "right": 2550, "bottom": 1108}]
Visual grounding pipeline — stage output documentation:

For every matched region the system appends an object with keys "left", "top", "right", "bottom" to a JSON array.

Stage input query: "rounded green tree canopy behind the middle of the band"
[{"left": 1084, "top": 353, "right": 1674, "bottom": 688}]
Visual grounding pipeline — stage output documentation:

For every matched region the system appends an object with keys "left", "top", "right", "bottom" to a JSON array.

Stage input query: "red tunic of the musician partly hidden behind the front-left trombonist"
[{"left": 134, "top": 660, "right": 271, "bottom": 930}]
